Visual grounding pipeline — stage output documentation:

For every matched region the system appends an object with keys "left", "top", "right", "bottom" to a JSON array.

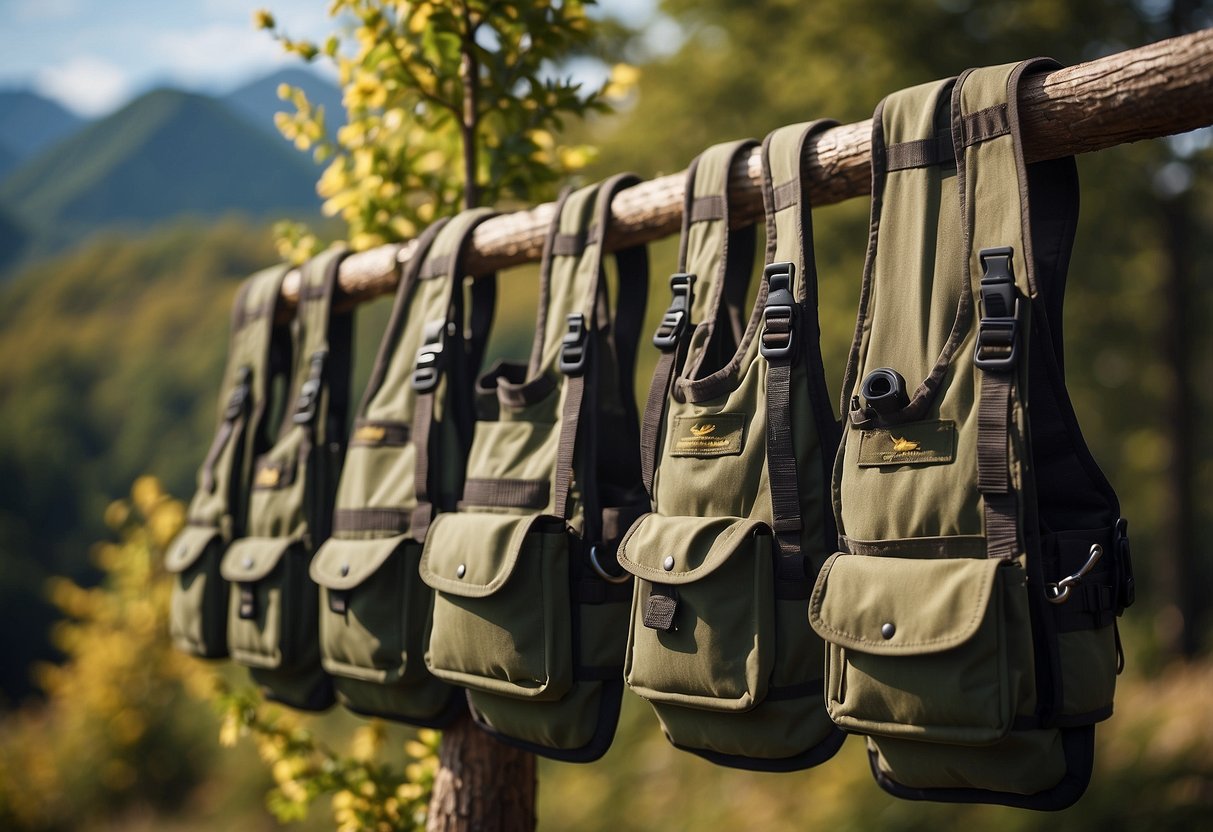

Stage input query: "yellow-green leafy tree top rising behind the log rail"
[{"left": 255, "top": 0, "right": 630, "bottom": 255}]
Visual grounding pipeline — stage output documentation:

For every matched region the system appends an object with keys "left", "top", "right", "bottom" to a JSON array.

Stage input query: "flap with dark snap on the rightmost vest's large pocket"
[{"left": 809, "top": 554, "right": 1010, "bottom": 656}]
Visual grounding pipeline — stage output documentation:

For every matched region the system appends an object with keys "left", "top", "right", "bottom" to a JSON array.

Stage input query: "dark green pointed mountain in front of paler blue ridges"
[{"left": 0, "top": 90, "right": 319, "bottom": 257}]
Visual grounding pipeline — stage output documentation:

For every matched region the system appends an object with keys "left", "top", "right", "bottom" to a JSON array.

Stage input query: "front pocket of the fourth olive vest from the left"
[{"left": 421, "top": 513, "right": 573, "bottom": 700}]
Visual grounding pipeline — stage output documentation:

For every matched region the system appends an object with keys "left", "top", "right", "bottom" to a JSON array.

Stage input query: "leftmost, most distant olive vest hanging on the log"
[{"left": 165, "top": 266, "right": 291, "bottom": 659}]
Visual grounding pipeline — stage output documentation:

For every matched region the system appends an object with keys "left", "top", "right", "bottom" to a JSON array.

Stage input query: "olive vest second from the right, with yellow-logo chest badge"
[{"left": 619, "top": 132, "right": 844, "bottom": 771}]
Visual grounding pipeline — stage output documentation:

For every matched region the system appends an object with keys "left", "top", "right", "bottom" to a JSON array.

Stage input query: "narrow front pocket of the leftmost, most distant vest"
[{"left": 164, "top": 526, "right": 228, "bottom": 659}]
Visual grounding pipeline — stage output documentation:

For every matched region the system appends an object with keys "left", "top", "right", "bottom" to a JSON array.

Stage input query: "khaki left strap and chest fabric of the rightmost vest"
[{"left": 836, "top": 81, "right": 983, "bottom": 540}]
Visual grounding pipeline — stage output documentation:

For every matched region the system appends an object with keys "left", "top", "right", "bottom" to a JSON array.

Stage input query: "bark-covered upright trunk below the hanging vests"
[{"left": 426, "top": 714, "right": 535, "bottom": 832}]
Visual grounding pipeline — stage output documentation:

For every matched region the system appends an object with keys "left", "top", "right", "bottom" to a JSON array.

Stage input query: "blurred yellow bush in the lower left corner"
[{"left": 0, "top": 478, "right": 215, "bottom": 830}]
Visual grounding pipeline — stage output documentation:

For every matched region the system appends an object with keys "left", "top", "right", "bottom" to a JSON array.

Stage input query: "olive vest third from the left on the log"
[{"left": 309, "top": 209, "right": 496, "bottom": 728}]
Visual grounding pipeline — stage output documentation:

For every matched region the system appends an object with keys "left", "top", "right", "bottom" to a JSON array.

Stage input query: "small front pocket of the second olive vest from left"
[{"left": 220, "top": 537, "right": 318, "bottom": 671}]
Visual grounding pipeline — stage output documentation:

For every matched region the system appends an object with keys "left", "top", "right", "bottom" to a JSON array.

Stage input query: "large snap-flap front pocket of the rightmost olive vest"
[{"left": 809, "top": 554, "right": 1033, "bottom": 746}]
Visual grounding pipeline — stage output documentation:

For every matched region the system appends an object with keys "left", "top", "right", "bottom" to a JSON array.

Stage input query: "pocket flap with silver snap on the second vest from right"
[{"left": 619, "top": 514, "right": 769, "bottom": 585}]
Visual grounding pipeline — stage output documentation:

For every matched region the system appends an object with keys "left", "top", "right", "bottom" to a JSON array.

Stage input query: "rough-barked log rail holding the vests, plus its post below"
[{"left": 272, "top": 30, "right": 1213, "bottom": 832}]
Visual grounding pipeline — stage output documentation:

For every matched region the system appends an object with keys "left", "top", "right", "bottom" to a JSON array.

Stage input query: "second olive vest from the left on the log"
[{"left": 220, "top": 251, "right": 352, "bottom": 711}]
